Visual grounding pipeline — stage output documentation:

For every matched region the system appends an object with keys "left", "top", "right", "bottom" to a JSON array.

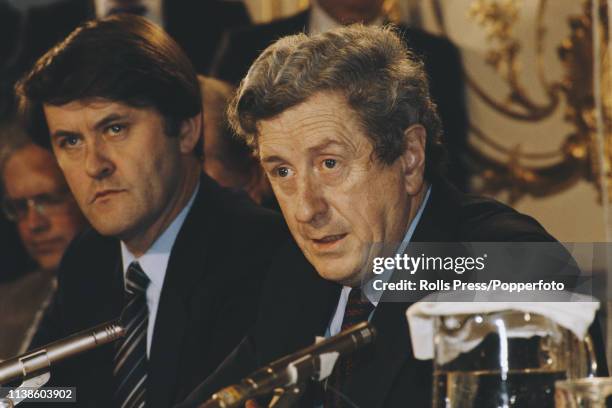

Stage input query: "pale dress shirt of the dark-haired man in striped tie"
[{"left": 121, "top": 184, "right": 200, "bottom": 357}]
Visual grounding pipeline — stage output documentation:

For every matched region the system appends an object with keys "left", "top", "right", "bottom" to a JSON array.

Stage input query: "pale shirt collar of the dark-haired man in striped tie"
[{"left": 121, "top": 182, "right": 200, "bottom": 288}]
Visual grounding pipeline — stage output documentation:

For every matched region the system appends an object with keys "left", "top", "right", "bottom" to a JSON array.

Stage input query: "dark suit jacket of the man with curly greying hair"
[{"left": 180, "top": 184, "right": 606, "bottom": 408}]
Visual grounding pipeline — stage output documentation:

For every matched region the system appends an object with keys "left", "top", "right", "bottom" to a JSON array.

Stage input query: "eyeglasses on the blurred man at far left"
[{"left": 2, "top": 190, "right": 71, "bottom": 222}]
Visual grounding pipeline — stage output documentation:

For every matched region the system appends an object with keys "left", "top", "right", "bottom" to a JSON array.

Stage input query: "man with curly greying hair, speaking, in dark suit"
[{"left": 181, "top": 26, "right": 605, "bottom": 408}]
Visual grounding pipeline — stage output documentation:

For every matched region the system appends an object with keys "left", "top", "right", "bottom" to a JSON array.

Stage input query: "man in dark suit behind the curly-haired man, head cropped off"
[{"left": 211, "top": 0, "right": 469, "bottom": 191}]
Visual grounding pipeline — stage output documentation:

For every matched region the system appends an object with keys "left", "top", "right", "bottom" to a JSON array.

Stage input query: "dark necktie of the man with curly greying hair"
[{"left": 323, "top": 288, "right": 374, "bottom": 408}]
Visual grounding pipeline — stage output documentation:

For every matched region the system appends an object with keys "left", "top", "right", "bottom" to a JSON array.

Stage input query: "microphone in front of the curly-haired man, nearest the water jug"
[{"left": 200, "top": 322, "right": 376, "bottom": 408}]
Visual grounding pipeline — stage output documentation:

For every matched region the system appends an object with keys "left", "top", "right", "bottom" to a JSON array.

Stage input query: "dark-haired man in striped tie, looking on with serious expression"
[{"left": 18, "top": 15, "right": 287, "bottom": 407}]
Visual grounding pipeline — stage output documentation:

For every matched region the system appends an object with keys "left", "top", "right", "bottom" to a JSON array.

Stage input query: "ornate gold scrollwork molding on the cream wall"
[{"left": 431, "top": 0, "right": 612, "bottom": 201}]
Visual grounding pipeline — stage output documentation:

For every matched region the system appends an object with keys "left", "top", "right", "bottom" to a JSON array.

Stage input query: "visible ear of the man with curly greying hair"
[{"left": 400, "top": 124, "right": 427, "bottom": 195}]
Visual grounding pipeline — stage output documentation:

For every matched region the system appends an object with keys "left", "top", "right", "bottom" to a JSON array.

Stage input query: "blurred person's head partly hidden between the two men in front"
[{"left": 199, "top": 76, "right": 278, "bottom": 209}]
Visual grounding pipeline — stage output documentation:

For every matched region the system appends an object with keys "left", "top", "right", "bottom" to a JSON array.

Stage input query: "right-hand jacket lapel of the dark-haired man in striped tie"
[{"left": 147, "top": 178, "right": 217, "bottom": 407}]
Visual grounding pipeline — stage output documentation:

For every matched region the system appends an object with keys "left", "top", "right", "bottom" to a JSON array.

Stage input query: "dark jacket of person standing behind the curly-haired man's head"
[{"left": 211, "top": 10, "right": 468, "bottom": 191}]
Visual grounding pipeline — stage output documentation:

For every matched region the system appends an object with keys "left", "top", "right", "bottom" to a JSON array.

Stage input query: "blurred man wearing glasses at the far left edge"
[{"left": 0, "top": 124, "right": 86, "bottom": 359}]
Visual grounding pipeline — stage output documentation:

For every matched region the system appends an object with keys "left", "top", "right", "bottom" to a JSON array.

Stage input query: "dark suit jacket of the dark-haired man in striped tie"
[{"left": 29, "top": 176, "right": 289, "bottom": 408}]
